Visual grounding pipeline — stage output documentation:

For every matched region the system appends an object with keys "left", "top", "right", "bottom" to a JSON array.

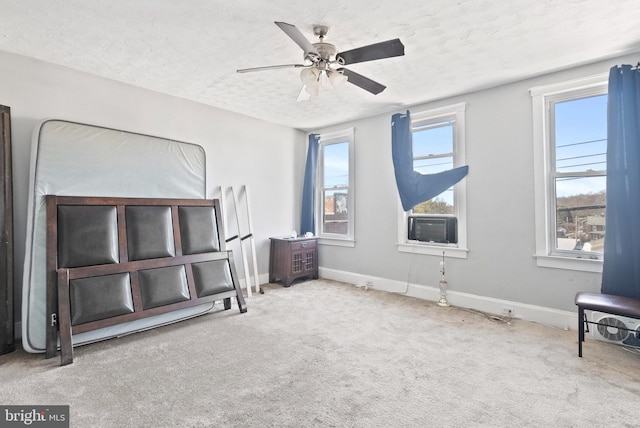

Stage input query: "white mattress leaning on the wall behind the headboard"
[{"left": 22, "top": 120, "right": 208, "bottom": 352}]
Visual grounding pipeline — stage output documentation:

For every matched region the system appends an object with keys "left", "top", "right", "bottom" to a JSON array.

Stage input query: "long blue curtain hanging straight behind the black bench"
[{"left": 602, "top": 65, "right": 640, "bottom": 298}]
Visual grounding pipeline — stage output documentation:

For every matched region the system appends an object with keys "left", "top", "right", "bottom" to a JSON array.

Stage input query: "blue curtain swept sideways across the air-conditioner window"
[{"left": 391, "top": 110, "right": 469, "bottom": 211}]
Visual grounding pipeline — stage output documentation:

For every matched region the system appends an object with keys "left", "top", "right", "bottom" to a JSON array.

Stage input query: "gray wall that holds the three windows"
[{"left": 319, "top": 52, "right": 637, "bottom": 311}]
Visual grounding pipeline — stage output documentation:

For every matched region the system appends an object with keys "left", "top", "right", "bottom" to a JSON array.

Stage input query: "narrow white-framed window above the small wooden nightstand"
[{"left": 316, "top": 129, "right": 355, "bottom": 245}]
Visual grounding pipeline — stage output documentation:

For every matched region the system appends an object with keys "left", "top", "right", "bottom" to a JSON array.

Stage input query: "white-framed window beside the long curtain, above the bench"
[{"left": 531, "top": 75, "right": 607, "bottom": 272}]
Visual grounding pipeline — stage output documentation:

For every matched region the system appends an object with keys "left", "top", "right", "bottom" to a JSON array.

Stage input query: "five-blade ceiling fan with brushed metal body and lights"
[{"left": 237, "top": 21, "right": 404, "bottom": 100}]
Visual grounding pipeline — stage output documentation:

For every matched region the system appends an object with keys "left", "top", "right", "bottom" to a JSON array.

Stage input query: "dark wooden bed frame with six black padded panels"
[{"left": 45, "top": 195, "right": 247, "bottom": 365}]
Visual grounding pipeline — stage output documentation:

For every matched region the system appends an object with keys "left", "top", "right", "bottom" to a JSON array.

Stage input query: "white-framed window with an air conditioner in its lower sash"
[{"left": 398, "top": 103, "right": 467, "bottom": 258}]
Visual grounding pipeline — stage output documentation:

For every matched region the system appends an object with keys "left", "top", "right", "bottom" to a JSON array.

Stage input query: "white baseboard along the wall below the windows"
[{"left": 319, "top": 268, "right": 578, "bottom": 330}]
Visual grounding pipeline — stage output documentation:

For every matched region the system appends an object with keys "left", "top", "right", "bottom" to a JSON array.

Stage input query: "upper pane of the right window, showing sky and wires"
[{"left": 555, "top": 95, "right": 607, "bottom": 173}]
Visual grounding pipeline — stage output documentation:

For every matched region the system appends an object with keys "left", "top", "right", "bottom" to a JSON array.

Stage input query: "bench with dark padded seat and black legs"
[{"left": 575, "top": 292, "right": 640, "bottom": 357}]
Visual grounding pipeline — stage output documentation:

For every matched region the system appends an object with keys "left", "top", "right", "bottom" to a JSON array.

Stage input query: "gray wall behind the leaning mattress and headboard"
[{"left": 0, "top": 52, "right": 306, "bottom": 317}]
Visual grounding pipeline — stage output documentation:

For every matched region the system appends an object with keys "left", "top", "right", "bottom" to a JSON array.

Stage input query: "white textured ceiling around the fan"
[{"left": 0, "top": 0, "right": 640, "bottom": 130}]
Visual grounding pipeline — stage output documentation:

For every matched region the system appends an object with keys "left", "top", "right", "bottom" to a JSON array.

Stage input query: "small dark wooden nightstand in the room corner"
[{"left": 269, "top": 237, "right": 318, "bottom": 287}]
